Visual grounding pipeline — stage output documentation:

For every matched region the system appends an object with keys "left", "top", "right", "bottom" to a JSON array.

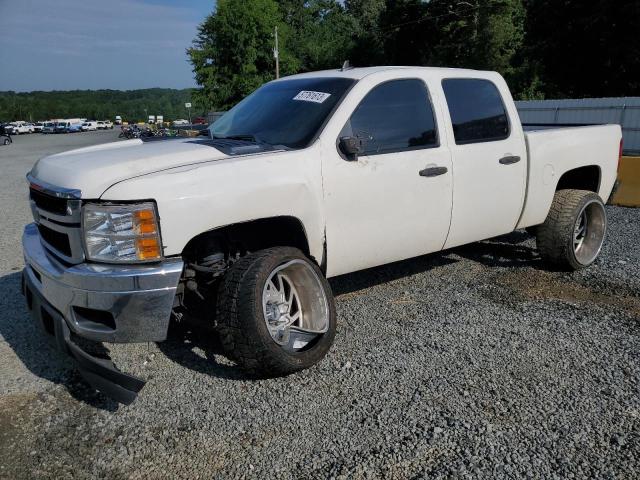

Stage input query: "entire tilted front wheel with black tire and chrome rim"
[{"left": 217, "top": 247, "right": 336, "bottom": 377}]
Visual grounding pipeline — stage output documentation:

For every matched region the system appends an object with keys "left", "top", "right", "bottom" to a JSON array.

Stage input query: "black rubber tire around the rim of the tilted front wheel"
[{"left": 216, "top": 247, "right": 336, "bottom": 377}]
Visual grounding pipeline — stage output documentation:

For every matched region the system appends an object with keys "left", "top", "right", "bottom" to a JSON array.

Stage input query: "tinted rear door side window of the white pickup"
[{"left": 442, "top": 78, "right": 509, "bottom": 145}]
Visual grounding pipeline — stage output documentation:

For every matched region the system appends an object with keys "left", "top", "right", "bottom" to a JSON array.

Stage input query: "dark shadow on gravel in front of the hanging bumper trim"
[{"left": 0, "top": 272, "right": 118, "bottom": 411}]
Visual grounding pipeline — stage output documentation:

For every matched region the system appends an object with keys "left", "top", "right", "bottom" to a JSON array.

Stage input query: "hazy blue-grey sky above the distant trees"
[{"left": 0, "top": 0, "right": 215, "bottom": 92}]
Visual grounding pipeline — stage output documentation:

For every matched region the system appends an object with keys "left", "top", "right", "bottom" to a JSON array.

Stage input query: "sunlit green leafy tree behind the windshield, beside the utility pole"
[{"left": 188, "top": 0, "right": 297, "bottom": 109}]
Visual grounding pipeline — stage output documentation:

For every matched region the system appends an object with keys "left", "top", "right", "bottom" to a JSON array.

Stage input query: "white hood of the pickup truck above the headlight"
[{"left": 31, "top": 138, "right": 229, "bottom": 198}]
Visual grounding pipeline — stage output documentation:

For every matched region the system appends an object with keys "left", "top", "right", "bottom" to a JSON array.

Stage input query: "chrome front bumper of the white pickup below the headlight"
[{"left": 22, "top": 223, "right": 184, "bottom": 343}]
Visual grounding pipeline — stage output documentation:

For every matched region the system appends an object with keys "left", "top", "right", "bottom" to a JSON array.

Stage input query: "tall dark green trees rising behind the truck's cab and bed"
[{"left": 188, "top": 0, "right": 640, "bottom": 109}]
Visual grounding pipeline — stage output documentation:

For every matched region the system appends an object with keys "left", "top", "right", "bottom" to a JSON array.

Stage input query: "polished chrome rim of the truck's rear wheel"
[{"left": 573, "top": 200, "right": 607, "bottom": 265}]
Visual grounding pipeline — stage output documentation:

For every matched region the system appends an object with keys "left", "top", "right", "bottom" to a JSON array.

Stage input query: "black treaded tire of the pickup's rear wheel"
[{"left": 536, "top": 190, "right": 607, "bottom": 270}]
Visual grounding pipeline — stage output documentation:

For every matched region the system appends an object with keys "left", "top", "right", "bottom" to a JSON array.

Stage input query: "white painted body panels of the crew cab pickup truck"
[{"left": 27, "top": 67, "right": 621, "bottom": 276}]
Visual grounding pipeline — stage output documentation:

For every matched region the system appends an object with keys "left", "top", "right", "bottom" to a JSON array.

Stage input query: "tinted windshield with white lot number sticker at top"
[{"left": 209, "top": 78, "right": 355, "bottom": 148}]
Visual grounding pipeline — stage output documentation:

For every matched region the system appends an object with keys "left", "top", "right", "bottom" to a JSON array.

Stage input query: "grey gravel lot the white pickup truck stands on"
[{"left": 0, "top": 130, "right": 640, "bottom": 479}]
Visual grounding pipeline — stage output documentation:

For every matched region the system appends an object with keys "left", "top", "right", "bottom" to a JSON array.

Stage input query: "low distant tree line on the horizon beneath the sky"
[{"left": 0, "top": 88, "right": 195, "bottom": 122}]
